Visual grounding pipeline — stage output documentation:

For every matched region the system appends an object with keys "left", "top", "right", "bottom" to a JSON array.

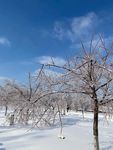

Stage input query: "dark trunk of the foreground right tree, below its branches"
[{"left": 93, "top": 99, "right": 99, "bottom": 150}]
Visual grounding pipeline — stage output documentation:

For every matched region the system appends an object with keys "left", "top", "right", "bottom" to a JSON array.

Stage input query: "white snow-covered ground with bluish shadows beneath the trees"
[{"left": 0, "top": 112, "right": 113, "bottom": 150}]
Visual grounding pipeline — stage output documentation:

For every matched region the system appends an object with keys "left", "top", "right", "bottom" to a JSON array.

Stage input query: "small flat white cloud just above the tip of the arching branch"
[{"left": 35, "top": 56, "right": 66, "bottom": 66}]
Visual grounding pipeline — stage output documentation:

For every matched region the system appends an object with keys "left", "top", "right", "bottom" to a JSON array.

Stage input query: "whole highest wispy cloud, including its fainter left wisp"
[{"left": 53, "top": 12, "right": 99, "bottom": 43}]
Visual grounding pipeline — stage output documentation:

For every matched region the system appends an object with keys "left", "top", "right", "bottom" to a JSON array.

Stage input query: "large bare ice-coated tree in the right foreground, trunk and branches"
[{"left": 47, "top": 37, "right": 113, "bottom": 150}]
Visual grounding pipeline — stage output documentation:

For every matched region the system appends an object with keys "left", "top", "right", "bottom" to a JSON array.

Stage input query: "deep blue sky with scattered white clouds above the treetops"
[{"left": 0, "top": 0, "right": 113, "bottom": 82}]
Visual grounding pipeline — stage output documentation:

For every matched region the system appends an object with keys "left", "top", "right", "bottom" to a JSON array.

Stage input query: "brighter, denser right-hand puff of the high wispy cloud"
[{"left": 68, "top": 13, "right": 98, "bottom": 42}]
